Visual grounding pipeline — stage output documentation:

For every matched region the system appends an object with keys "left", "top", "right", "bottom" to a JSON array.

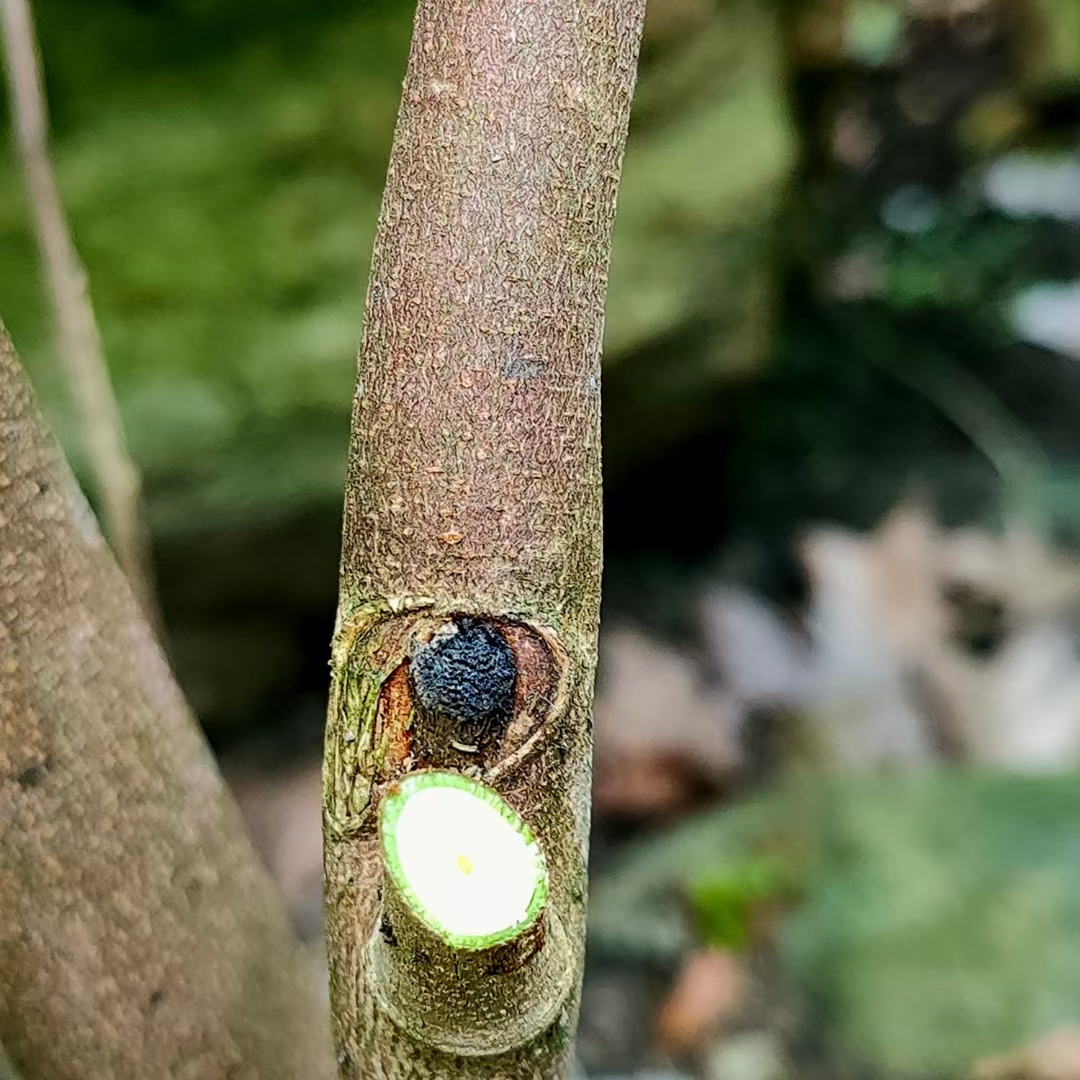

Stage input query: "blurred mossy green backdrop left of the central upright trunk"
[{"left": 0, "top": 2, "right": 409, "bottom": 531}]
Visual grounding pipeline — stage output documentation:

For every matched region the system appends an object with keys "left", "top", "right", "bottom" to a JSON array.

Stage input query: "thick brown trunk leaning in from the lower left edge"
[{"left": 0, "top": 327, "right": 333, "bottom": 1080}]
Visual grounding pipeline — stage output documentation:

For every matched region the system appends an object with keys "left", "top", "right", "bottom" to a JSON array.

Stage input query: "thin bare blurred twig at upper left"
[{"left": 0, "top": 0, "right": 157, "bottom": 620}]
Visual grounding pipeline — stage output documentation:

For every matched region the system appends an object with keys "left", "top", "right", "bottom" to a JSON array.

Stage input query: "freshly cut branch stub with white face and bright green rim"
[{"left": 368, "top": 769, "right": 573, "bottom": 1056}]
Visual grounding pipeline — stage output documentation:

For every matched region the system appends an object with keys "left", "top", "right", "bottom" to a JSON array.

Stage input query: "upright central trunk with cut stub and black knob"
[{"left": 324, "top": 0, "right": 645, "bottom": 1080}]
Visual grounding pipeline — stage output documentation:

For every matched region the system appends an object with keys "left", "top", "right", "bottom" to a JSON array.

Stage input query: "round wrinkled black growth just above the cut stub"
[{"left": 409, "top": 618, "right": 517, "bottom": 726}]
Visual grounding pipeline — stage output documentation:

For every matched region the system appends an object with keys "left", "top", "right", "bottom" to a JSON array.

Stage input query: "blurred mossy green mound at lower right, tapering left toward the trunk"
[{"left": 590, "top": 769, "right": 1080, "bottom": 1080}]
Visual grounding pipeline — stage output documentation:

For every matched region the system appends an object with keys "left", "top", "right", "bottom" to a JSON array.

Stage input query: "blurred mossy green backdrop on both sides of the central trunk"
[{"left": 0, "top": 0, "right": 792, "bottom": 537}]
